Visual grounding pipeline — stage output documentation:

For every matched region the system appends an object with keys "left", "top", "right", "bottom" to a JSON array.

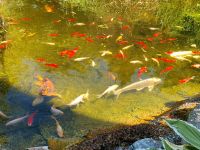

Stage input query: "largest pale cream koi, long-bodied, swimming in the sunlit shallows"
[{"left": 114, "top": 77, "right": 162, "bottom": 98}]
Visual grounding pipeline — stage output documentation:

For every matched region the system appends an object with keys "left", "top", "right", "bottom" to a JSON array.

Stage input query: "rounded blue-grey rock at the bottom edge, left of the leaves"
[{"left": 128, "top": 138, "right": 162, "bottom": 150}]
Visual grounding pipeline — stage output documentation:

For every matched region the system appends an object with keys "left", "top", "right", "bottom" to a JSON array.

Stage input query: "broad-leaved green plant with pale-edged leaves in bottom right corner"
[{"left": 162, "top": 119, "right": 200, "bottom": 150}]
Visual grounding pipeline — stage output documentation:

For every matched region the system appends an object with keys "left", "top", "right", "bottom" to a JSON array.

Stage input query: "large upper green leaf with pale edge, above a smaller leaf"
[{"left": 166, "top": 119, "right": 200, "bottom": 149}]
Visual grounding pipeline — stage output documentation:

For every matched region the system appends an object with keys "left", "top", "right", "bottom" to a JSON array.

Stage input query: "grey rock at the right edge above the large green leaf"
[{"left": 188, "top": 104, "right": 200, "bottom": 129}]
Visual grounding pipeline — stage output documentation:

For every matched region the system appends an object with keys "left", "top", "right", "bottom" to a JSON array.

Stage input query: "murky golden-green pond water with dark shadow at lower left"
[{"left": 0, "top": 0, "right": 200, "bottom": 149}]
